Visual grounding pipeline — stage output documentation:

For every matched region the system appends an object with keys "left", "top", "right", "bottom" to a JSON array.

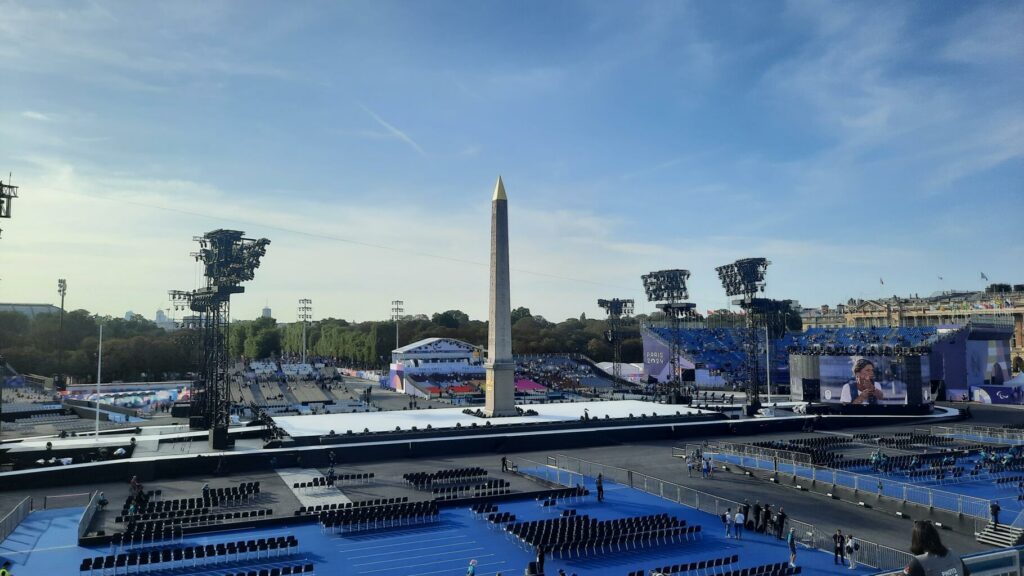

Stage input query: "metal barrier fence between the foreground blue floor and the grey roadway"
[{"left": 515, "top": 453, "right": 912, "bottom": 570}]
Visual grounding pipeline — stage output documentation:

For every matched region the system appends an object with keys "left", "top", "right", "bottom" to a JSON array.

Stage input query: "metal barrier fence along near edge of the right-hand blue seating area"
[{"left": 706, "top": 444, "right": 990, "bottom": 521}]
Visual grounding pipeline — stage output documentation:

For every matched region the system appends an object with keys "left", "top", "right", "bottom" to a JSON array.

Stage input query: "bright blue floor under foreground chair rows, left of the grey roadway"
[{"left": 0, "top": 483, "right": 874, "bottom": 576}]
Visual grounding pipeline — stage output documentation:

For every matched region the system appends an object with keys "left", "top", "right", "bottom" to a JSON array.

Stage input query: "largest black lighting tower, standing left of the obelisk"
[{"left": 170, "top": 230, "right": 270, "bottom": 449}]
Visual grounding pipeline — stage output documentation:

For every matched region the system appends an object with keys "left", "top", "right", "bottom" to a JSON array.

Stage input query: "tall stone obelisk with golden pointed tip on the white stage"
[{"left": 483, "top": 176, "right": 516, "bottom": 416}]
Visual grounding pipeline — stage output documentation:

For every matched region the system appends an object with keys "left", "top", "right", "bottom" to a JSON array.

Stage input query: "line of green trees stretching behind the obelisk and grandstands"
[{"left": 0, "top": 307, "right": 799, "bottom": 382}]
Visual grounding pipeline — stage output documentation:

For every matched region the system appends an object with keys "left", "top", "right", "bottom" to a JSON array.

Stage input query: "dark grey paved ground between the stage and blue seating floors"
[{"left": 0, "top": 397, "right": 1024, "bottom": 553}]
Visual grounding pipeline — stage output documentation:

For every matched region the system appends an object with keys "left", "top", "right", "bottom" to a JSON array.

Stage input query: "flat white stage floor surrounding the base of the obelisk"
[{"left": 273, "top": 400, "right": 705, "bottom": 438}]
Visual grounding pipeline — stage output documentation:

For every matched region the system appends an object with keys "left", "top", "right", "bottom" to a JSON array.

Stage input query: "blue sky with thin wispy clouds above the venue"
[{"left": 0, "top": 0, "right": 1024, "bottom": 321}]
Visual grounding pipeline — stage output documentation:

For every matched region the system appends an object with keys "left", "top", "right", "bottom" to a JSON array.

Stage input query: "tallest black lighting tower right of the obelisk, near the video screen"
[{"left": 715, "top": 258, "right": 771, "bottom": 415}]
